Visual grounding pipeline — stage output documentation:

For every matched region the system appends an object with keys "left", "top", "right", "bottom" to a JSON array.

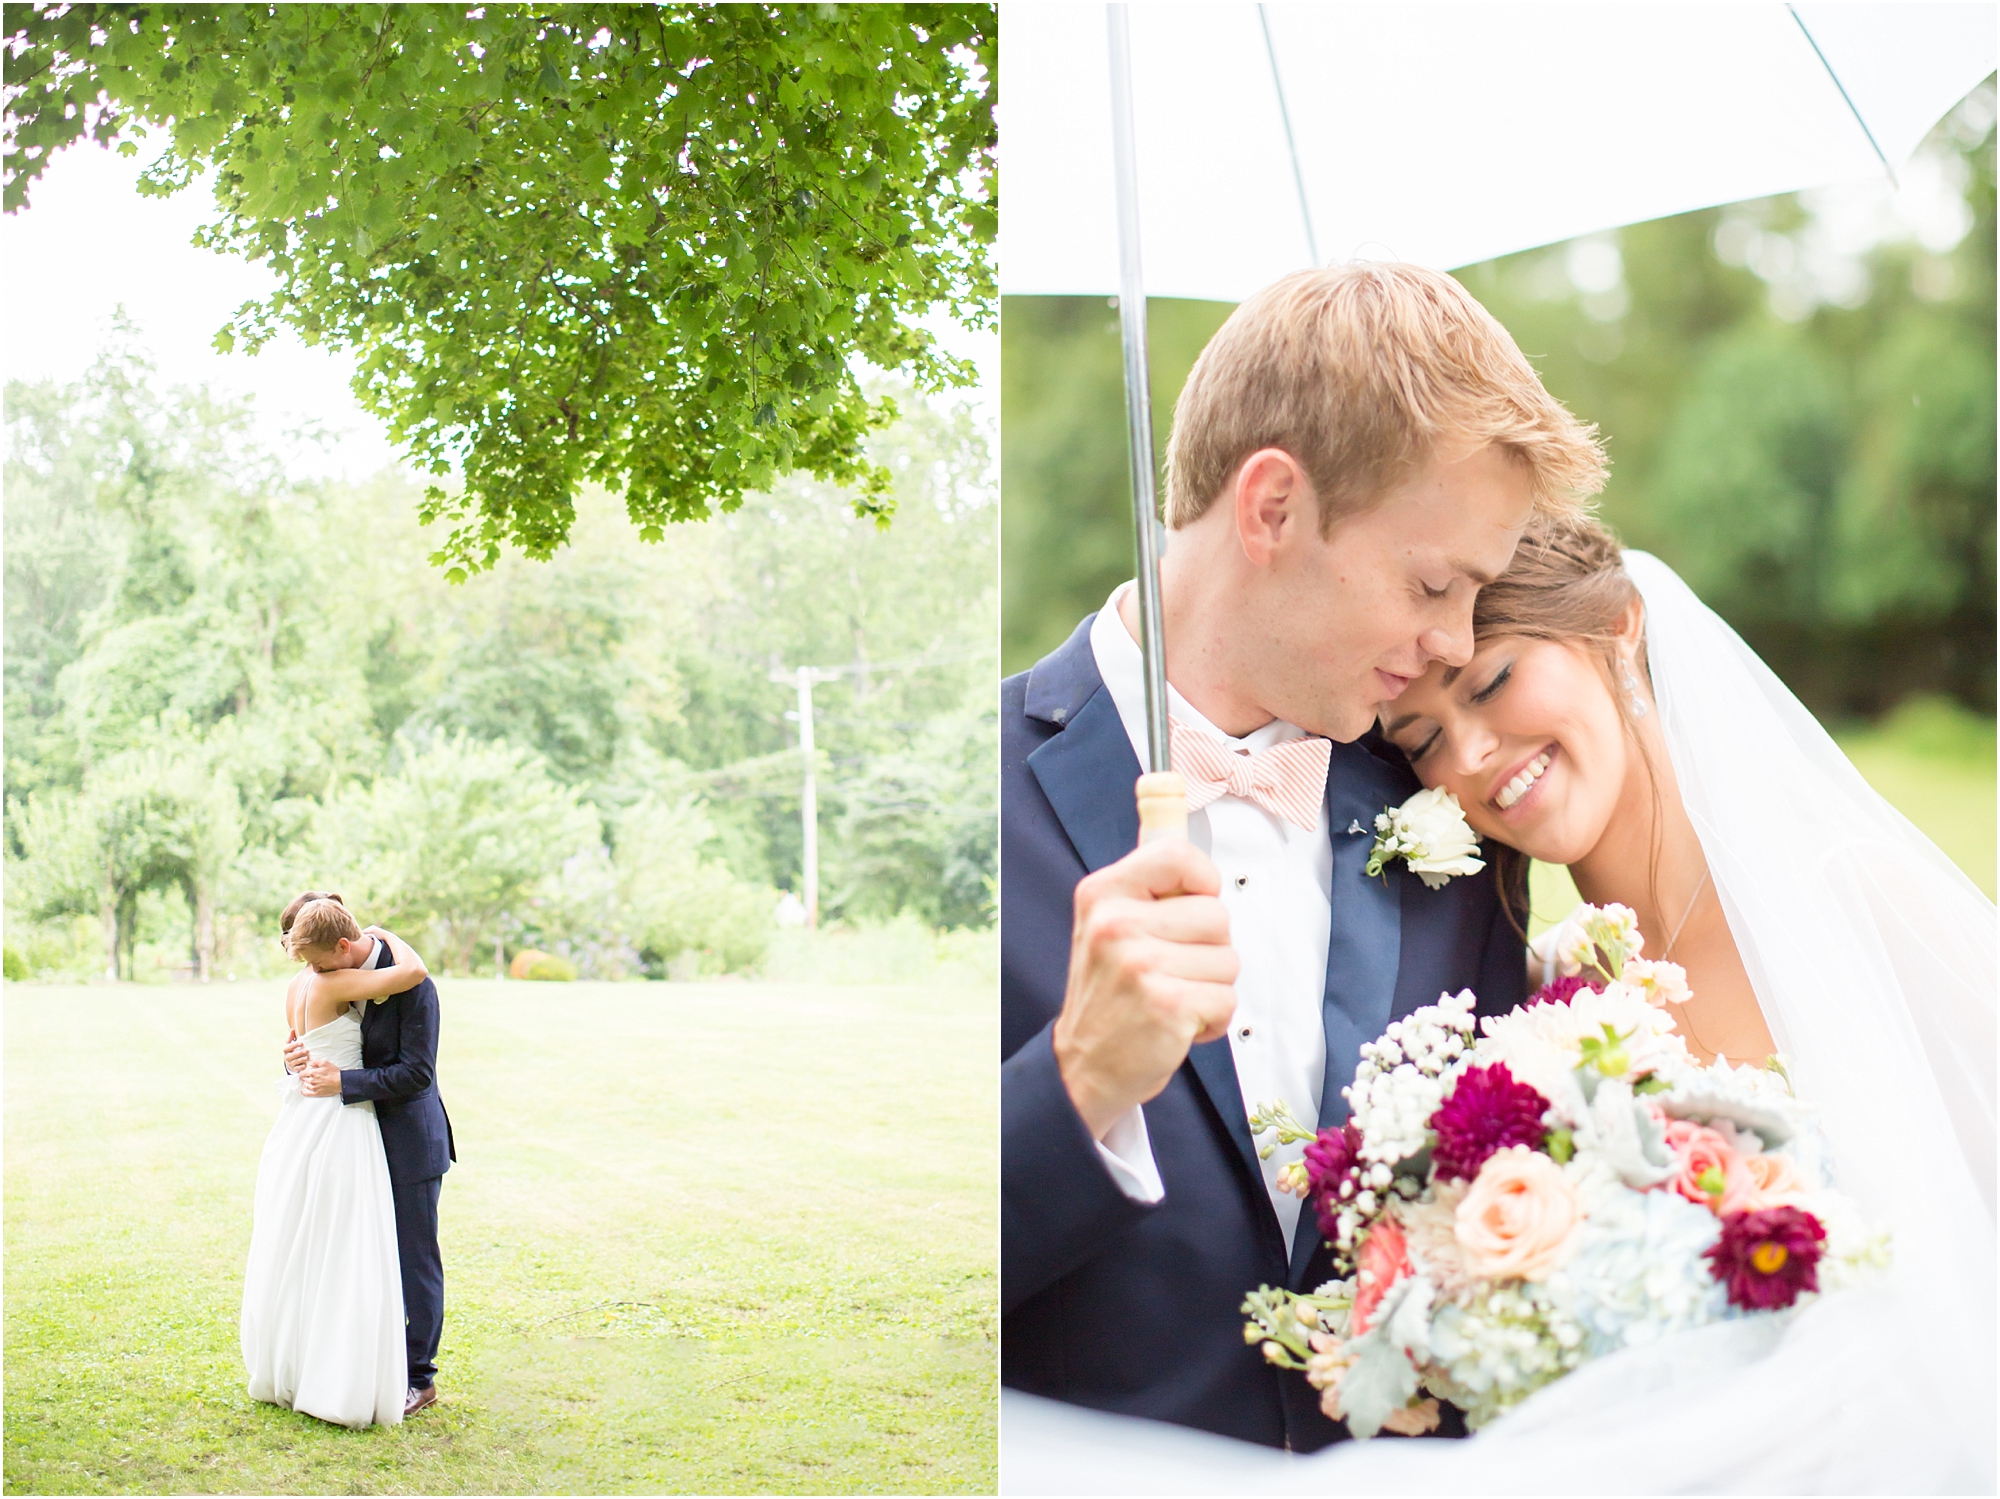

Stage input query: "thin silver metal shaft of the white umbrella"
[{"left": 1104, "top": 4, "right": 1172, "bottom": 771}]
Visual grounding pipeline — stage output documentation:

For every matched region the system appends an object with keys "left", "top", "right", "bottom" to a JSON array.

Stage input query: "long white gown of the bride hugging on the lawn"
[{"left": 242, "top": 1009, "right": 410, "bottom": 1427}]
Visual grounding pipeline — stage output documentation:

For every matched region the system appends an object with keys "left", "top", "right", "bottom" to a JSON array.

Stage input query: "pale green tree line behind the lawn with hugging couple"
[{"left": 6, "top": 348, "right": 996, "bottom": 991}]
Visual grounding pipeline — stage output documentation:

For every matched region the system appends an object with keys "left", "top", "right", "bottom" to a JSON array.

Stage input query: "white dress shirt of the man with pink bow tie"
[{"left": 1090, "top": 584, "right": 1334, "bottom": 1243}]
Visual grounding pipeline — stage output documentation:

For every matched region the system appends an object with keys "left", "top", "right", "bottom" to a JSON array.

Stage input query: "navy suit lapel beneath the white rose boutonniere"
[{"left": 1292, "top": 744, "right": 1408, "bottom": 1285}]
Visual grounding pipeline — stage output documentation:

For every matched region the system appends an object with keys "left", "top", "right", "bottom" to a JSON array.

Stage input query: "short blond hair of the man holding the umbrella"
[{"left": 1166, "top": 262, "right": 1604, "bottom": 536}]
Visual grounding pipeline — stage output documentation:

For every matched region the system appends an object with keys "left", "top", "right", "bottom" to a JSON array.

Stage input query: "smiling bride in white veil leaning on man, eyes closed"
[{"left": 1000, "top": 522, "right": 1996, "bottom": 1493}]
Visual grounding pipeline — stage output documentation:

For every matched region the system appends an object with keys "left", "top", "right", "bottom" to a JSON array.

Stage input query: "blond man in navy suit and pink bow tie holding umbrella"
[{"left": 1000, "top": 266, "right": 1602, "bottom": 1451}]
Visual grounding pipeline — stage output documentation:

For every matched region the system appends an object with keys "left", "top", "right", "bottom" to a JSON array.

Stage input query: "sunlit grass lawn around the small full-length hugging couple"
[{"left": 4, "top": 979, "right": 998, "bottom": 1493}]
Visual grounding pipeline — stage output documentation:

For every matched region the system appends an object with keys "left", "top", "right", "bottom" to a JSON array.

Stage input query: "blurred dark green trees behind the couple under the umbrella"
[{"left": 1002, "top": 80, "right": 1994, "bottom": 722}]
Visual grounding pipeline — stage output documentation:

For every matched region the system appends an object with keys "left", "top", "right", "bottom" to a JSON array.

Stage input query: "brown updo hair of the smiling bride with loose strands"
[{"left": 1472, "top": 514, "right": 1664, "bottom": 915}]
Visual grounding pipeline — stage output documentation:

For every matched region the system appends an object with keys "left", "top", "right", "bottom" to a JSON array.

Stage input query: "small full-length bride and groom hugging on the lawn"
[{"left": 242, "top": 891, "right": 456, "bottom": 1427}]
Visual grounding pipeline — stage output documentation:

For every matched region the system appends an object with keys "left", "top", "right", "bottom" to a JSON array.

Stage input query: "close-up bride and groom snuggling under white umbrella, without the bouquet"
[{"left": 1002, "top": 264, "right": 1996, "bottom": 1491}]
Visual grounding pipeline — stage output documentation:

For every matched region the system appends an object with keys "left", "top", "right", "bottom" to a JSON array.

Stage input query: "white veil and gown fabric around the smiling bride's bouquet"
[{"left": 1000, "top": 552, "right": 2000, "bottom": 1493}]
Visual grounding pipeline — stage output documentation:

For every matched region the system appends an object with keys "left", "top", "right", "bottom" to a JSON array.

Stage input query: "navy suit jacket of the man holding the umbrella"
[{"left": 1000, "top": 620, "right": 1526, "bottom": 1451}]
